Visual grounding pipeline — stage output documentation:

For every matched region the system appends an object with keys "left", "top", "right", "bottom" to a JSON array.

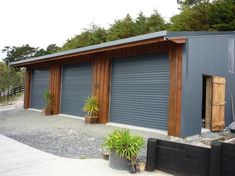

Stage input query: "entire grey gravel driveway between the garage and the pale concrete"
[{"left": 0, "top": 108, "right": 167, "bottom": 159}]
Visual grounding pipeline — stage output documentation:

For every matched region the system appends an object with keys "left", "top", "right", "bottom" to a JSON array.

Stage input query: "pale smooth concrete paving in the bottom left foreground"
[{"left": 0, "top": 135, "right": 170, "bottom": 176}]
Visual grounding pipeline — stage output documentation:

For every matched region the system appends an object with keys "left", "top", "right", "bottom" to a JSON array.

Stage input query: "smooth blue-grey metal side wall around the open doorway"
[{"left": 181, "top": 35, "right": 235, "bottom": 137}]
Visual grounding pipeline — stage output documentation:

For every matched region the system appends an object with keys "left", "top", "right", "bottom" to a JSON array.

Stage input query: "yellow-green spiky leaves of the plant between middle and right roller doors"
[{"left": 83, "top": 96, "right": 100, "bottom": 116}]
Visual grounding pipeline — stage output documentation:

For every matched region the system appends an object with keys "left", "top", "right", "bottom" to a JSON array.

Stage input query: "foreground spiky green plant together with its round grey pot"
[{"left": 103, "top": 130, "right": 144, "bottom": 173}]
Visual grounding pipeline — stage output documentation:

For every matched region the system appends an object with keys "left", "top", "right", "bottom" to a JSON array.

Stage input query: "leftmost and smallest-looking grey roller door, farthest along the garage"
[{"left": 31, "top": 68, "right": 50, "bottom": 109}]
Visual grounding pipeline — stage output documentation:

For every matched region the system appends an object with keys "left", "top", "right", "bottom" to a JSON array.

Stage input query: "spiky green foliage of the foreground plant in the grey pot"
[{"left": 103, "top": 130, "right": 144, "bottom": 163}]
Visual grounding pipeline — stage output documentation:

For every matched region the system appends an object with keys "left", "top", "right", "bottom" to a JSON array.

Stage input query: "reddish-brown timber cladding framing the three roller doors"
[{"left": 25, "top": 39, "right": 183, "bottom": 136}]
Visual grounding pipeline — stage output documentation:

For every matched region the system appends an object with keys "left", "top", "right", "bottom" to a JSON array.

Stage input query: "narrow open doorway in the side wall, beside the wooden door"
[{"left": 202, "top": 75, "right": 213, "bottom": 129}]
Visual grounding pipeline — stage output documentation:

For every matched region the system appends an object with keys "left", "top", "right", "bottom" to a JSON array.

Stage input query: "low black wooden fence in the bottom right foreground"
[{"left": 146, "top": 138, "right": 235, "bottom": 176}]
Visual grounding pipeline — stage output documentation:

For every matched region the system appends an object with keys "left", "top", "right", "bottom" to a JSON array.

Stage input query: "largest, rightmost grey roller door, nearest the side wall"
[{"left": 110, "top": 54, "right": 169, "bottom": 130}]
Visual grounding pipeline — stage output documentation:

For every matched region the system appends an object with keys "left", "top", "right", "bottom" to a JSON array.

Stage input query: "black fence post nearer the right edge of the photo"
[{"left": 209, "top": 141, "right": 222, "bottom": 176}]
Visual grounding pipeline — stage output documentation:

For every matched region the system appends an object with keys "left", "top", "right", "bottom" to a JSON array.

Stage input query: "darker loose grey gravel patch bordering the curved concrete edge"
[{"left": 8, "top": 129, "right": 103, "bottom": 158}]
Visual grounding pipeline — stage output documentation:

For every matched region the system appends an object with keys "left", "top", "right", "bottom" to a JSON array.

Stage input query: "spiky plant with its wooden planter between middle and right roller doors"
[{"left": 83, "top": 96, "right": 100, "bottom": 123}]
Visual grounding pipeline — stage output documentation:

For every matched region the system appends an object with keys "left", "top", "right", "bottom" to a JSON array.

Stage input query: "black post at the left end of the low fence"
[{"left": 146, "top": 138, "right": 157, "bottom": 172}]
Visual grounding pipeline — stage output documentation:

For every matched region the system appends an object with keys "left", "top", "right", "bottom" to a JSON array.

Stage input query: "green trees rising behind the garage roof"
[{"left": 0, "top": 0, "right": 235, "bottom": 99}]
